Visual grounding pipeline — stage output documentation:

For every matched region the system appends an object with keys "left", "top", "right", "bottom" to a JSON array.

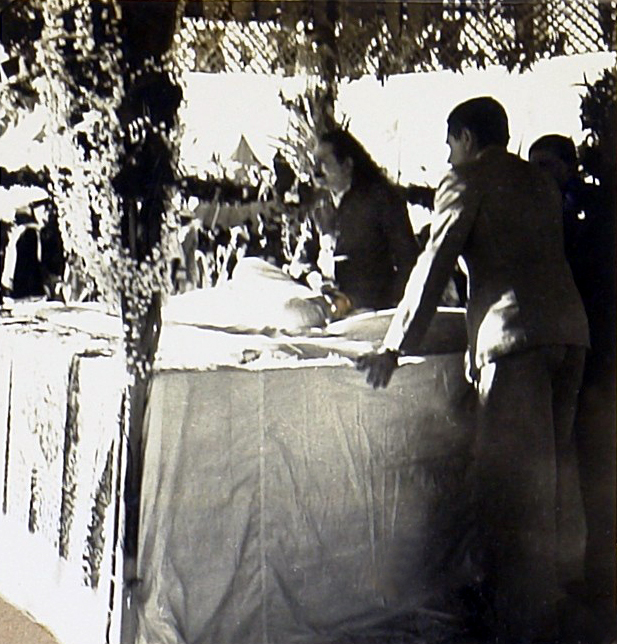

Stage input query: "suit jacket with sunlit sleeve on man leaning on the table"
[{"left": 383, "top": 146, "right": 589, "bottom": 369}]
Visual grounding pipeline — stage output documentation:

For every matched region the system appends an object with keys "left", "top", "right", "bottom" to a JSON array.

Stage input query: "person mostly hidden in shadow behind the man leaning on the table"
[{"left": 529, "top": 134, "right": 617, "bottom": 632}]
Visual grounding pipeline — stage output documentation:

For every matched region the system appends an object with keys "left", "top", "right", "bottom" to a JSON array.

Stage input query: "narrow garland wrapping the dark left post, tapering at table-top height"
[{"left": 114, "top": 0, "right": 185, "bottom": 382}]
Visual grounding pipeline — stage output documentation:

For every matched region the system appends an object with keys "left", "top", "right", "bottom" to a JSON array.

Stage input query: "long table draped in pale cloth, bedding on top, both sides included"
[{"left": 0, "top": 278, "right": 580, "bottom": 644}]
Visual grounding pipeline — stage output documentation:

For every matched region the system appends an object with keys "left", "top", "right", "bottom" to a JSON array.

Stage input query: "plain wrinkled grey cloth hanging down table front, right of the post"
[{"left": 135, "top": 310, "right": 472, "bottom": 644}]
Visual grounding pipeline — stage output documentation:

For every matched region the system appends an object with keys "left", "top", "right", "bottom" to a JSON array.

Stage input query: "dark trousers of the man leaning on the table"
[{"left": 475, "top": 345, "right": 585, "bottom": 641}]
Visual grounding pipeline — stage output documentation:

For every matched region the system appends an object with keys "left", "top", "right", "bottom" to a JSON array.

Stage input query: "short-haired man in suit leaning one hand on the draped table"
[{"left": 357, "top": 97, "right": 606, "bottom": 644}]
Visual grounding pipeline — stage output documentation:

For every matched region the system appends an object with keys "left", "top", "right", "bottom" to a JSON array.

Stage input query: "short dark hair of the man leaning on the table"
[{"left": 448, "top": 96, "right": 510, "bottom": 150}]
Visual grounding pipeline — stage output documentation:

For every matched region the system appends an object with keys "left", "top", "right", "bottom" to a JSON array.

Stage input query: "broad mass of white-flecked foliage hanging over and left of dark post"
[{"left": 10, "top": 0, "right": 182, "bottom": 382}]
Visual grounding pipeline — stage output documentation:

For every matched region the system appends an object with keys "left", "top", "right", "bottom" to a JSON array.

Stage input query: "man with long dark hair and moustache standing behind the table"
[{"left": 292, "top": 129, "right": 420, "bottom": 309}]
